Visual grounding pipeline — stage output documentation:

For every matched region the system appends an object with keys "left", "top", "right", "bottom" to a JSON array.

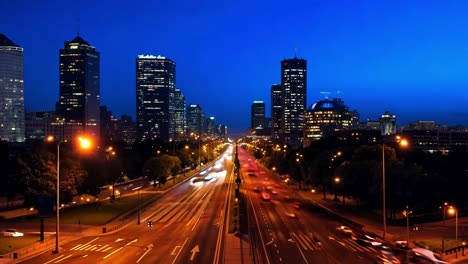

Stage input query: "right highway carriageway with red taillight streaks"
[{"left": 239, "top": 148, "right": 386, "bottom": 263}]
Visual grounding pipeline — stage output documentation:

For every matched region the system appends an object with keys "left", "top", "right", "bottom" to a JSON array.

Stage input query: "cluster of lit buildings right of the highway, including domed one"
[{"left": 249, "top": 57, "right": 468, "bottom": 153}]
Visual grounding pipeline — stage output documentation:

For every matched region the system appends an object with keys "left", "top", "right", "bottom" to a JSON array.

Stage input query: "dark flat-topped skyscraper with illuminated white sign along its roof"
[{"left": 136, "top": 55, "right": 176, "bottom": 142}]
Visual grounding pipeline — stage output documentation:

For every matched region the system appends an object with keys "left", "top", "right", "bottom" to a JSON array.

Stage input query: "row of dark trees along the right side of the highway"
[{"left": 254, "top": 139, "right": 468, "bottom": 217}]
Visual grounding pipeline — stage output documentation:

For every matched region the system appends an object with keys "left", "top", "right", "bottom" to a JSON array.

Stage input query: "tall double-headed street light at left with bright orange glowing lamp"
[{"left": 47, "top": 136, "right": 92, "bottom": 254}]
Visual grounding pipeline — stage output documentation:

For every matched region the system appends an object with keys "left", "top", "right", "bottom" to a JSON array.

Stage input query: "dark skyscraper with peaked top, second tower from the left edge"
[{"left": 57, "top": 36, "right": 100, "bottom": 139}]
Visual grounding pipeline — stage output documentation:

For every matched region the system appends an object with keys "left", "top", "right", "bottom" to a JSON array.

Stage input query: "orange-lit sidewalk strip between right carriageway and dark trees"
[{"left": 296, "top": 185, "right": 468, "bottom": 263}]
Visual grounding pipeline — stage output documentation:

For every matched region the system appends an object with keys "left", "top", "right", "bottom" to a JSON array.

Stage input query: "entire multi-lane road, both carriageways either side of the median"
[{"left": 23, "top": 144, "right": 392, "bottom": 264}]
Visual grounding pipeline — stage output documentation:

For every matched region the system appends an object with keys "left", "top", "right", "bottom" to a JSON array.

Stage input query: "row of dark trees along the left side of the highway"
[{"left": 0, "top": 140, "right": 223, "bottom": 206}]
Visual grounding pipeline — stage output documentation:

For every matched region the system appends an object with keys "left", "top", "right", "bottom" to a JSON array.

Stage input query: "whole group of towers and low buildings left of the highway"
[{"left": 0, "top": 34, "right": 227, "bottom": 146}]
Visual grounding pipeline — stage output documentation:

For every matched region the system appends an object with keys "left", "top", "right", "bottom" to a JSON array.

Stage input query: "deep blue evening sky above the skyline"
[{"left": 0, "top": 0, "right": 468, "bottom": 132}]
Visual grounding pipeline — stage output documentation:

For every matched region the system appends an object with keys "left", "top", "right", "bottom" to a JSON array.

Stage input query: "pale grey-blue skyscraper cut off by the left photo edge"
[{"left": 0, "top": 34, "right": 25, "bottom": 142}]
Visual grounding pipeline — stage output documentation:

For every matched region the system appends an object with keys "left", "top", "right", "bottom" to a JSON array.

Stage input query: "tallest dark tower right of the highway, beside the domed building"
[{"left": 281, "top": 57, "right": 307, "bottom": 146}]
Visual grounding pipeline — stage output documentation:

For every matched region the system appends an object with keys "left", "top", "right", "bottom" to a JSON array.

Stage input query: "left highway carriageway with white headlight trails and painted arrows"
[{"left": 23, "top": 145, "right": 232, "bottom": 264}]
